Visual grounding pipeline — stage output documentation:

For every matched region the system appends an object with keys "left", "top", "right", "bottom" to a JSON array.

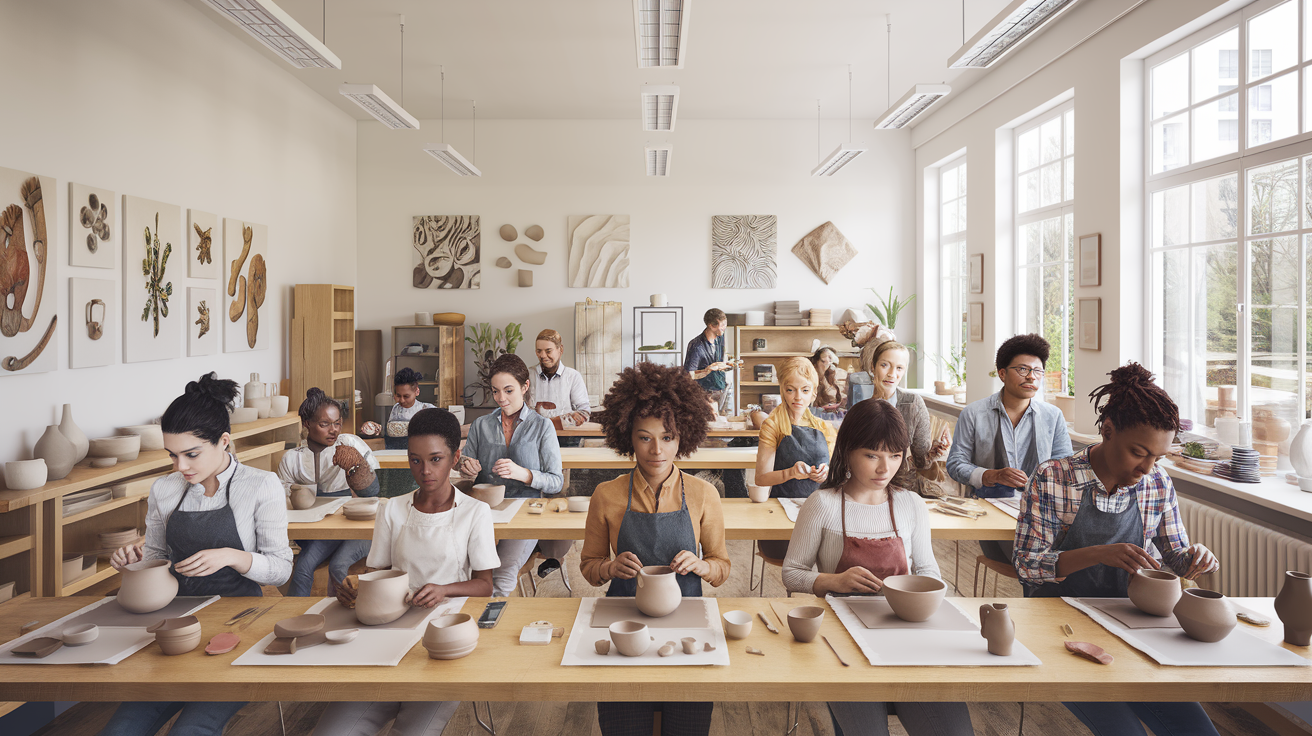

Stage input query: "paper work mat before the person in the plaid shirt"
[{"left": 1061, "top": 598, "right": 1312, "bottom": 666}]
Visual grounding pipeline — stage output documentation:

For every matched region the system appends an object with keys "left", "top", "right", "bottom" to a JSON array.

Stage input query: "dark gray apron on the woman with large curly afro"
[{"left": 606, "top": 468, "right": 702, "bottom": 598}]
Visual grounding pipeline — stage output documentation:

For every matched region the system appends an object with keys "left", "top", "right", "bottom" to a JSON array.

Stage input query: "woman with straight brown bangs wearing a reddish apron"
[{"left": 783, "top": 399, "right": 975, "bottom": 736}]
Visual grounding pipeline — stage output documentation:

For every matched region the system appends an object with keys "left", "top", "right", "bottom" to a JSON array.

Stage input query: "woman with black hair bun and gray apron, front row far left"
[{"left": 101, "top": 374, "right": 291, "bottom": 736}]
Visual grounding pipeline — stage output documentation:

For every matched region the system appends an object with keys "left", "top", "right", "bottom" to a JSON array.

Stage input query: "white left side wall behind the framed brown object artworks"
[{"left": 0, "top": 0, "right": 356, "bottom": 460}]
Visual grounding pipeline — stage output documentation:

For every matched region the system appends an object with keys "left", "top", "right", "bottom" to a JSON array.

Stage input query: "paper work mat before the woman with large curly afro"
[{"left": 560, "top": 598, "right": 729, "bottom": 666}]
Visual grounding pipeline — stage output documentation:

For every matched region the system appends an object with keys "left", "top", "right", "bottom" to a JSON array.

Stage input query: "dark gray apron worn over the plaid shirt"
[{"left": 1022, "top": 481, "right": 1144, "bottom": 598}]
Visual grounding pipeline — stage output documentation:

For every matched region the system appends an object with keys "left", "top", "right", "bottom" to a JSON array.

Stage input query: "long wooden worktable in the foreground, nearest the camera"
[{"left": 0, "top": 596, "right": 1312, "bottom": 702}]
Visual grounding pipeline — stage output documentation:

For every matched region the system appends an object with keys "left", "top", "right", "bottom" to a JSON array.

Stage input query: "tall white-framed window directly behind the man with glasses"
[{"left": 1015, "top": 101, "right": 1075, "bottom": 395}]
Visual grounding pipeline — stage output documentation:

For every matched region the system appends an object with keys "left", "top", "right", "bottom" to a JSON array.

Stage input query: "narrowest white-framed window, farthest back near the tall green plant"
[{"left": 937, "top": 156, "right": 970, "bottom": 384}]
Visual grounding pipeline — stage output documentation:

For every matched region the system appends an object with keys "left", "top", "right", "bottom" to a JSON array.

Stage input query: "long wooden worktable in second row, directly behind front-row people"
[{"left": 287, "top": 499, "right": 1015, "bottom": 541}]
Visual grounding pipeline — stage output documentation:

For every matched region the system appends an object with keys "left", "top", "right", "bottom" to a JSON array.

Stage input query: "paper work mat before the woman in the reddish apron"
[{"left": 825, "top": 596, "right": 1043, "bottom": 666}]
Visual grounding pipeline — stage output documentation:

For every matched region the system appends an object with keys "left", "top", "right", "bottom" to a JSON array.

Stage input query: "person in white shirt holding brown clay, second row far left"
[{"left": 278, "top": 388, "right": 378, "bottom": 596}]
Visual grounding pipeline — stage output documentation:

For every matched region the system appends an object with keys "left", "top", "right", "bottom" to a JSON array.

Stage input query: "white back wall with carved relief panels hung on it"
[{"left": 357, "top": 119, "right": 916, "bottom": 401}]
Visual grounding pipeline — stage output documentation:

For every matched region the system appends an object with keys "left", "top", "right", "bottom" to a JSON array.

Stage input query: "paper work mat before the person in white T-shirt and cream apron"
[{"left": 232, "top": 597, "right": 468, "bottom": 666}]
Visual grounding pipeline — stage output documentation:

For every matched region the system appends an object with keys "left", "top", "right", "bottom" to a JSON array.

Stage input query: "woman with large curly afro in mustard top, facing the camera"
[{"left": 580, "top": 362, "right": 729, "bottom": 736}]
